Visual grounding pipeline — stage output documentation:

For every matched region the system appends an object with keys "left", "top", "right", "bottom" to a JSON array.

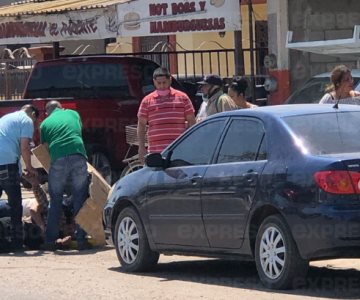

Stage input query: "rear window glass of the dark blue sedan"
[{"left": 283, "top": 111, "right": 360, "bottom": 155}]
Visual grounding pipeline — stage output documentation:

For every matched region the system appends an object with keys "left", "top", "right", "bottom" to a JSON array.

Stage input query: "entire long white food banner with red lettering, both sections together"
[{"left": 0, "top": 0, "right": 241, "bottom": 44}]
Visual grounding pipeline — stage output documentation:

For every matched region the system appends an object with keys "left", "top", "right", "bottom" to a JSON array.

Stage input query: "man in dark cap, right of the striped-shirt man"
[{"left": 196, "top": 74, "right": 237, "bottom": 122}]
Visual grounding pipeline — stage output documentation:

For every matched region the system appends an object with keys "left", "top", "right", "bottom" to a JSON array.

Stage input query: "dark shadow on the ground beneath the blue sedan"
[{"left": 110, "top": 260, "right": 360, "bottom": 299}]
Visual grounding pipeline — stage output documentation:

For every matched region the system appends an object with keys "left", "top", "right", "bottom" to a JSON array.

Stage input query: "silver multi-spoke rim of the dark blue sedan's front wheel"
[{"left": 117, "top": 217, "right": 139, "bottom": 264}]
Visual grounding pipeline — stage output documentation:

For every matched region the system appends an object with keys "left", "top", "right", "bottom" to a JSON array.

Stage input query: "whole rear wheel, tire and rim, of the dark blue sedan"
[{"left": 255, "top": 215, "right": 309, "bottom": 289}]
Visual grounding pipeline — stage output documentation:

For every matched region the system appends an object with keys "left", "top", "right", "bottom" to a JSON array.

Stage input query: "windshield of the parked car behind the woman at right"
[{"left": 286, "top": 77, "right": 360, "bottom": 104}]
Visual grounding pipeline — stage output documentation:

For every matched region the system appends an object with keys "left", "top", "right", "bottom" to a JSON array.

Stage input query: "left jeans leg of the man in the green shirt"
[{"left": 45, "top": 157, "right": 70, "bottom": 244}]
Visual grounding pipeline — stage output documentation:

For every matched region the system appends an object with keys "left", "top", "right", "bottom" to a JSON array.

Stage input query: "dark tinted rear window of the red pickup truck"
[{"left": 26, "top": 63, "right": 141, "bottom": 98}]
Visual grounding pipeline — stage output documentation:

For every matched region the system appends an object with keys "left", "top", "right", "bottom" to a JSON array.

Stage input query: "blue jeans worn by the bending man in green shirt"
[{"left": 45, "top": 154, "right": 89, "bottom": 243}]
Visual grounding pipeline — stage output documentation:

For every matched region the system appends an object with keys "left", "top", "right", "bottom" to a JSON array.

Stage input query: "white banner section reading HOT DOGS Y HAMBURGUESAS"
[{"left": 118, "top": 0, "right": 241, "bottom": 36}]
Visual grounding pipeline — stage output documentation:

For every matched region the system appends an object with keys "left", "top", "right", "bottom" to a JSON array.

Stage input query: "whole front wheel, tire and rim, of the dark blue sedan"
[{"left": 114, "top": 207, "right": 159, "bottom": 272}]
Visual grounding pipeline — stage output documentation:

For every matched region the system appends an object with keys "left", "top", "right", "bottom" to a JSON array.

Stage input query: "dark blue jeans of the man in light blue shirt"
[{"left": 0, "top": 164, "right": 23, "bottom": 245}]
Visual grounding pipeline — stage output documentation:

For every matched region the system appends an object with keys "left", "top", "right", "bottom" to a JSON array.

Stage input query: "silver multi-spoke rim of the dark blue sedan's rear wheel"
[{"left": 260, "top": 227, "right": 287, "bottom": 279}]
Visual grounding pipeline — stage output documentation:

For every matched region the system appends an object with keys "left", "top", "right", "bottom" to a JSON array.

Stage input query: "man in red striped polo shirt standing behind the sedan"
[{"left": 137, "top": 68, "right": 195, "bottom": 163}]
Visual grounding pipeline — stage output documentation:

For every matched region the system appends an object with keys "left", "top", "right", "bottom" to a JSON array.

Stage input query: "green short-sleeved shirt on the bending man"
[{"left": 40, "top": 108, "right": 87, "bottom": 162}]
